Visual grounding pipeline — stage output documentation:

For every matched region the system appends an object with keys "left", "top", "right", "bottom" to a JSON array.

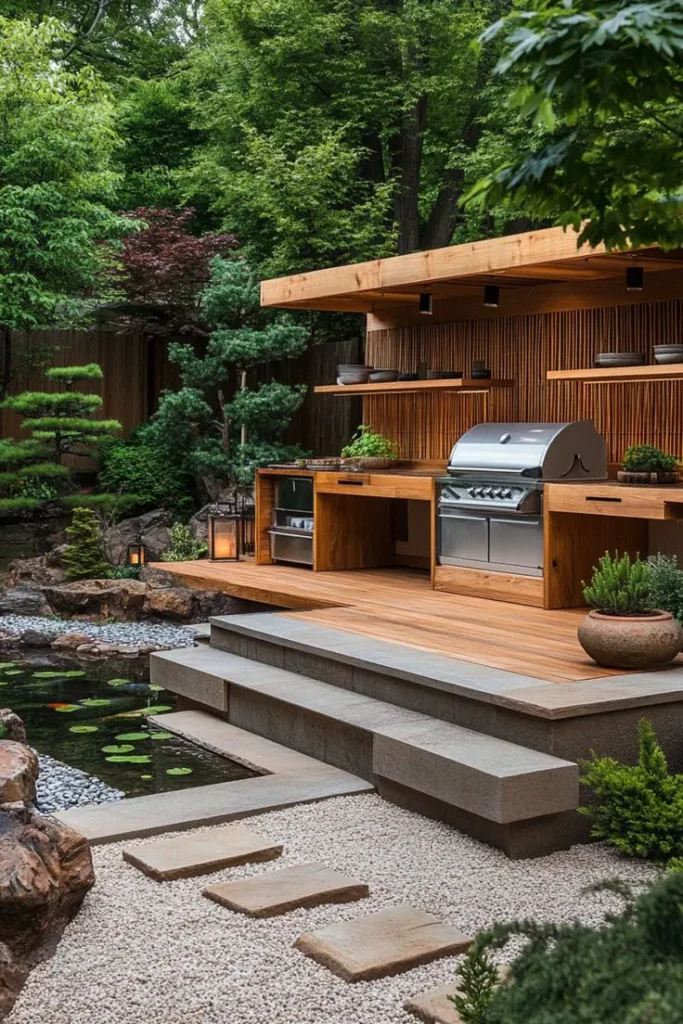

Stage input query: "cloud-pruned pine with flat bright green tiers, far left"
[{"left": 0, "top": 362, "right": 121, "bottom": 509}]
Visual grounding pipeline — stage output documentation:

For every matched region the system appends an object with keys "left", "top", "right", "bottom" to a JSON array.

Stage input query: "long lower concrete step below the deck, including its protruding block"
[{"left": 151, "top": 647, "right": 579, "bottom": 856}]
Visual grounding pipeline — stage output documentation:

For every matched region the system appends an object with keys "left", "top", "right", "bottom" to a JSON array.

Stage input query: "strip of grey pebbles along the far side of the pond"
[{"left": 0, "top": 615, "right": 195, "bottom": 650}]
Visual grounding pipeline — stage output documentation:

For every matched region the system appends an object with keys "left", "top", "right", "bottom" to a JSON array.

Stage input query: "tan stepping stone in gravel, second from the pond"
[{"left": 204, "top": 863, "right": 370, "bottom": 918}]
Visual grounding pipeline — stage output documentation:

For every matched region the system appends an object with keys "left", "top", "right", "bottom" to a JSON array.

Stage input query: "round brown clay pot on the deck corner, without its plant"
[{"left": 579, "top": 609, "right": 683, "bottom": 669}]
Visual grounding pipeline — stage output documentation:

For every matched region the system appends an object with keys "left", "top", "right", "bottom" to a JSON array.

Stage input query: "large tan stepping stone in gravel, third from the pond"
[{"left": 295, "top": 904, "right": 472, "bottom": 981}]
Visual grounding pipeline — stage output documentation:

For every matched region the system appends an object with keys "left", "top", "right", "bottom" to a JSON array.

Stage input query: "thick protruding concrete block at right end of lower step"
[{"left": 373, "top": 719, "right": 579, "bottom": 823}]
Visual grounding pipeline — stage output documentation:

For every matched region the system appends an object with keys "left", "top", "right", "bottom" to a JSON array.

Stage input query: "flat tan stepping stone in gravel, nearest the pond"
[{"left": 123, "top": 824, "right": 283, "bottom": 882}]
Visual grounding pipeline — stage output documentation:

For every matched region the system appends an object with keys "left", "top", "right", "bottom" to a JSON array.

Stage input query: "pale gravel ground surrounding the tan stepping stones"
[{"left": 7, "top": 795, "right": 654, "bottom": 1024}]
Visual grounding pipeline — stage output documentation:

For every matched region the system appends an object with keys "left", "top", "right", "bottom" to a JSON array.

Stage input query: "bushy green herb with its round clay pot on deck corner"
[{"left": 579, "top": 552, "right": 683, "bottom": 669}]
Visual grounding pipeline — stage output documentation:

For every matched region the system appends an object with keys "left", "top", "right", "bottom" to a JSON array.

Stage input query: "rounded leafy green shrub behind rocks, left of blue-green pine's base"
[{"left": 99, "top": 440, "right": 197, "bottom": 515}]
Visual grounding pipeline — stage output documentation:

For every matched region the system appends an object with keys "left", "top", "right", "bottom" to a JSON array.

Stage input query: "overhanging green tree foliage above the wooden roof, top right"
[{"left": 470, "top": 0, "right": 683, "bottom": 248}]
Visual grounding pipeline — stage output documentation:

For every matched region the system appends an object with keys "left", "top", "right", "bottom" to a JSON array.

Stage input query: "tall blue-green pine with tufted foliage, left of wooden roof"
[{"left": 148, "top": 257, "right": 308, "bottom": 500}]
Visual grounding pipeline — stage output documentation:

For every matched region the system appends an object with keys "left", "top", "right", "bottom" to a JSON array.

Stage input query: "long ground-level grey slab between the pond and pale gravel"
[{"left": 55, "top": 765, "right": 374, "bottom": 846}]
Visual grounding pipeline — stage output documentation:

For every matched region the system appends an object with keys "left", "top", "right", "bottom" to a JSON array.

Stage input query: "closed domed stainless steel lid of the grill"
[{"left": 449, "top": 420, "right": 607, "bottom": 480}]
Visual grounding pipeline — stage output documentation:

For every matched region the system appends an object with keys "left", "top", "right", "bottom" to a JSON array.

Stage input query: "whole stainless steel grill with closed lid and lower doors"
[{"left": 438, "top": 420, "right": 607, "bottom": 575}]
